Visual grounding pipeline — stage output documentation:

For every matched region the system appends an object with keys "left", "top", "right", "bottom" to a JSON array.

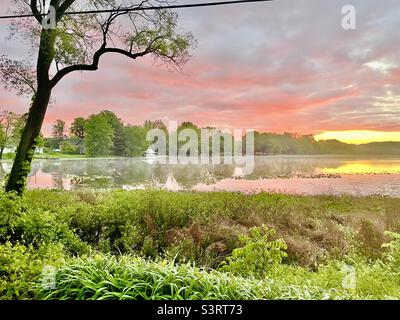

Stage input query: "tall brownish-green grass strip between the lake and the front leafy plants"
[{"left": 27, "top": 191, "right": 400, "bottom": 267}]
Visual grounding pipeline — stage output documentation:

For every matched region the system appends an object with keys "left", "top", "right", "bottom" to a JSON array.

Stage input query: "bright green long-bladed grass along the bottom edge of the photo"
[{"left": 36, "top": 255, "right": 400, "bottom": 300}]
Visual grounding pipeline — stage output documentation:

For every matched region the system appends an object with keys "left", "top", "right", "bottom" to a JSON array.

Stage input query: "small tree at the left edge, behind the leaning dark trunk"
[{"left": 0, "top": 110, "right": 26, "bottom": 159}]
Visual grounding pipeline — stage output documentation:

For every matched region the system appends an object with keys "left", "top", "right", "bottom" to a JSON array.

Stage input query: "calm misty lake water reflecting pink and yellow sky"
[{"left": 0, "top": 156, "right": 400, "bottom": 197}]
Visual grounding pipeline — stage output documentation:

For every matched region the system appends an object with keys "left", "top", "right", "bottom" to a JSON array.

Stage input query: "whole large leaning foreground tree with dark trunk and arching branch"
[{"left": 0, "top": 0, "right": 193, "bottom": 193}]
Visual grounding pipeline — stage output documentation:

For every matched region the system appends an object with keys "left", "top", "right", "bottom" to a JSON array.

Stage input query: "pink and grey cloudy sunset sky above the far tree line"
[{"left": 0, "top": 0, "right": 400, "bottom": 142}]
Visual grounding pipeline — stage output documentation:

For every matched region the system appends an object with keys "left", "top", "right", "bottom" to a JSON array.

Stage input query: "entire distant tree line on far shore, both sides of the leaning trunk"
[{"left": 0, "top": 110, "right": 400, "bottom": 159}]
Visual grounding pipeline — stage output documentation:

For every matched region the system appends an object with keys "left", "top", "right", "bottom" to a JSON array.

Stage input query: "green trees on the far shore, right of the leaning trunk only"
[{"left": 47, "top": 114, "right": 400, "bottom": 157}]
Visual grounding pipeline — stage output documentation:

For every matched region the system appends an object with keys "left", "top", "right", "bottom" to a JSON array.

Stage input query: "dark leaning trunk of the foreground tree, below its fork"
[{"left": 6, "top": 87, "right": 51, "bottom": 194}]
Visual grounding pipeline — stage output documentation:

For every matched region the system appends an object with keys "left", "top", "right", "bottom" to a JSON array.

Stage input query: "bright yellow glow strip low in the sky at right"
[{"left": 315, "top": 130, "right": 400, "bottom": 144}]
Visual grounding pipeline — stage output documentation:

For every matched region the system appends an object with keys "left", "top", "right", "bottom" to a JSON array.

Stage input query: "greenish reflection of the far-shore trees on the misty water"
[{"left": 9, "top": 156, "right": 366, "bottom": 189}]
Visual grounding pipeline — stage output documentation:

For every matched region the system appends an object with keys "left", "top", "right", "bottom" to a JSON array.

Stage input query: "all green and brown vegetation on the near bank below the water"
[{"left": 0, "top": 190, "right": 400, "bottom": 299}]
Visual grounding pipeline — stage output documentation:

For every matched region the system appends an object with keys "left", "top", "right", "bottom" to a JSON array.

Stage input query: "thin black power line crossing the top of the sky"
[{"left": 0, "top": 0, "right": 275, "bottom": 19}]
